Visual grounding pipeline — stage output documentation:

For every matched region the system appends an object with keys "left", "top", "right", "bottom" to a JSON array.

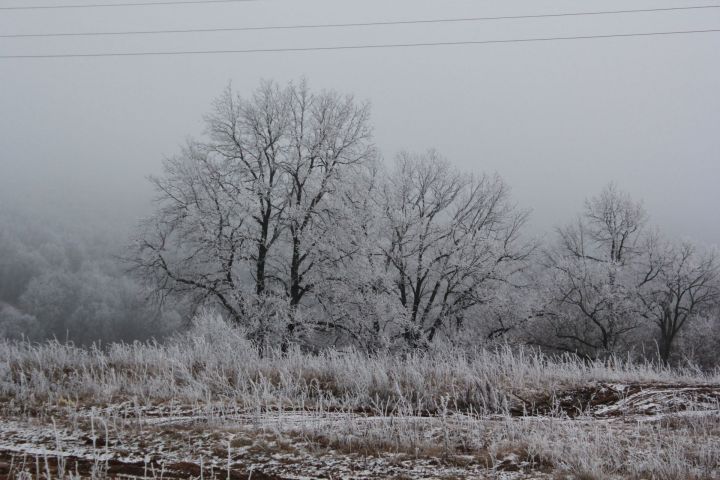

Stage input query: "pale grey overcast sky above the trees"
[{"left": 0, "top": 0, "right": 720, "bottom": 240}]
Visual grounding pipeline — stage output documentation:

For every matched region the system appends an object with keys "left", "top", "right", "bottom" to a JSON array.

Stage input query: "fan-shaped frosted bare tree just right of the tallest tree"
[{"left": 381, "top": 151, "right": 532, "bottom": 346}]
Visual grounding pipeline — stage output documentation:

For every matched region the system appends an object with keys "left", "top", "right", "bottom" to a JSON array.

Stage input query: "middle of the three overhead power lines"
[{"left": 0, "top": 2, "right": 720, "bottom": 38}]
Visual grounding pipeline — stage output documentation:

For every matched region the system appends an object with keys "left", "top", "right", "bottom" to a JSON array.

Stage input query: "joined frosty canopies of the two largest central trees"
[{"left": 133, "top": 81, "right": 533, "bottom": 347}]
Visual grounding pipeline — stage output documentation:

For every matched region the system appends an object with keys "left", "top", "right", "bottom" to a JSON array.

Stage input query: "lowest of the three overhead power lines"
[{"left": 0, "top": 29, "right": 720, "bottom": 59}]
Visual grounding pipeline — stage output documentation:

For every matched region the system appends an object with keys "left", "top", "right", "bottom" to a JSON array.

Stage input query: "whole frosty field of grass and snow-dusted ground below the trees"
[{"left": 0, "top": 316, "right": 720, "bottom": 480}]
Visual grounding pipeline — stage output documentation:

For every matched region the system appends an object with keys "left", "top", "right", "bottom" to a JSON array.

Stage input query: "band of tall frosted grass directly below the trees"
[{"left": 0, "top": 316, "right": 720, "bottom": 413}]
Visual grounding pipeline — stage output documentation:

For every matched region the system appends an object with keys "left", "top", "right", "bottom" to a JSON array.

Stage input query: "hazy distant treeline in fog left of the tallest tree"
[{"left": 0, "top": 210, "right": 183, "bottom": 344}]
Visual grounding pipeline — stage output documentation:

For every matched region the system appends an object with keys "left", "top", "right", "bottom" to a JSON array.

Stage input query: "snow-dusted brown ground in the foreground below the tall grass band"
[{"left": 0, "top": 384, "right": 720, "bottom": 480}]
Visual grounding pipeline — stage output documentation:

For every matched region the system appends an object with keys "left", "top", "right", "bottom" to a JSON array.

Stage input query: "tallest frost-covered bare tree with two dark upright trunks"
[{"left": 134, "top": 82, "right": 375, "bottom": 344}]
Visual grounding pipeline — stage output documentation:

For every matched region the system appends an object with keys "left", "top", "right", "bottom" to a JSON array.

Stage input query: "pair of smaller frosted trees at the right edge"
[{"left": 531, "top": 184, "right": 718, "bottom": 362}]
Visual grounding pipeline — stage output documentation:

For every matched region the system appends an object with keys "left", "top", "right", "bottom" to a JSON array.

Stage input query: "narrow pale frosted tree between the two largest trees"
[{"left": 308, "top": 162, "right": 407, "bottom": 350}]
